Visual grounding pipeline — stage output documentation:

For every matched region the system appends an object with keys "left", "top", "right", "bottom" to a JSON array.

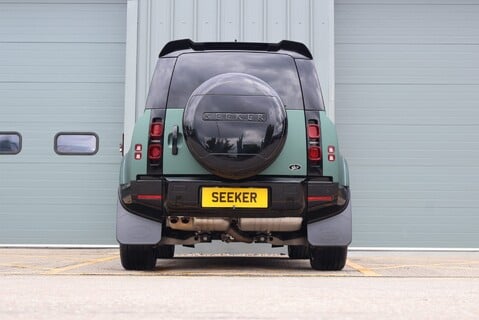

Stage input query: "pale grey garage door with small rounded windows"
[{"left": 0, "top": 0, "right": 126, "bottom": 244}]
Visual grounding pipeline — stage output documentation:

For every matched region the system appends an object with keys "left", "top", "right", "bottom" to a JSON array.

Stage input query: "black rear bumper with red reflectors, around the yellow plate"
[{"left": 119, "top": 177, "right": 349, "bottom": 222}]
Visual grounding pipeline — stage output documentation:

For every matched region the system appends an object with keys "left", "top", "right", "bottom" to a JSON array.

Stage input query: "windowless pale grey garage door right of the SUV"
[{"left": 335, "top": 0, "right": 479, "bottom": 248}]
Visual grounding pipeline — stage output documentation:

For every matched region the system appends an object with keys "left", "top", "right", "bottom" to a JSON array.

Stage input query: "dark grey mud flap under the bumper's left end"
[{"left": 116, "top": 201, "right": 162, "bottom": 244}]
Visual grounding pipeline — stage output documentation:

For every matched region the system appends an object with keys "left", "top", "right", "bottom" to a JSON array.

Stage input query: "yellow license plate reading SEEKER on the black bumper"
[{"left": 201, "top": 187, "right": 268, "bottom": 208}]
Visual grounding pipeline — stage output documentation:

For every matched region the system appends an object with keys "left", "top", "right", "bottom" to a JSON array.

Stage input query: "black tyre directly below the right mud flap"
[{"left": 309, "top": 246, "right": 348, "bottom": 271}]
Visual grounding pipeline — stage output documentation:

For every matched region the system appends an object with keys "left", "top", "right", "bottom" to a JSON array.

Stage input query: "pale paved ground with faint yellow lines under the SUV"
[{"left": 0, "top": 248, "right": 479, "bottom": 319}]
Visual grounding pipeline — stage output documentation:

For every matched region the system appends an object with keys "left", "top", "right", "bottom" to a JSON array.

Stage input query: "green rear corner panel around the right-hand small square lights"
[{"left": 320, "top": 111, "right": 349, "bottom": 186}]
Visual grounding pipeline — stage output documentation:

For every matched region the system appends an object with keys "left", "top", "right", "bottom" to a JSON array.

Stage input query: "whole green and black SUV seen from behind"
[{"left": 117, "top": 40, "right": 352, "bottom": 270}]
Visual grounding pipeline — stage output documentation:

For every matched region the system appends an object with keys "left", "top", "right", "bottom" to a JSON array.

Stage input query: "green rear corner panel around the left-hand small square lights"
[{"left": 120, "top": 110, "right": 151, "bottom": 184}]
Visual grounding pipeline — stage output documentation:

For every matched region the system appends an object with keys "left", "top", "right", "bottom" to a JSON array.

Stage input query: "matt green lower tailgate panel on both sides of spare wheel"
[{"left": 163, "top": 109, "right": 307, "bottom": 176}]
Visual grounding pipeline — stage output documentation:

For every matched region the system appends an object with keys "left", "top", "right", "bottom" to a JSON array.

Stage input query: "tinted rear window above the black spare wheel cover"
[{"left": 168, "top": 52, "right": 303, "bottom": 109}]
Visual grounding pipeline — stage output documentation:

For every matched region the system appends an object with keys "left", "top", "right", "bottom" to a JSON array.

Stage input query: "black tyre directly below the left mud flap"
[{"left": 120, "top": 244, "right": 156, "bottom": 270}]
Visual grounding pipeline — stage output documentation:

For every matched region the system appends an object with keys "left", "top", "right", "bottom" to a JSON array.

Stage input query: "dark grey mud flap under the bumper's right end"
[{"left": 308, "top": 201, "right": 352, "bottom": 247}]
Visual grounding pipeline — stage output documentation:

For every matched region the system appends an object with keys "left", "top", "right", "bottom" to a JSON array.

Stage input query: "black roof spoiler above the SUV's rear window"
[{"left": 160, "top": 39, "right": 313, "bottom": 59}]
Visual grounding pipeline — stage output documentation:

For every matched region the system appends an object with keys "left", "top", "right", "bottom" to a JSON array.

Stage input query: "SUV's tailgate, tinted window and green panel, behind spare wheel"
[{"left": 163, "top": 52, "right": 307, "bottom": 176}]
